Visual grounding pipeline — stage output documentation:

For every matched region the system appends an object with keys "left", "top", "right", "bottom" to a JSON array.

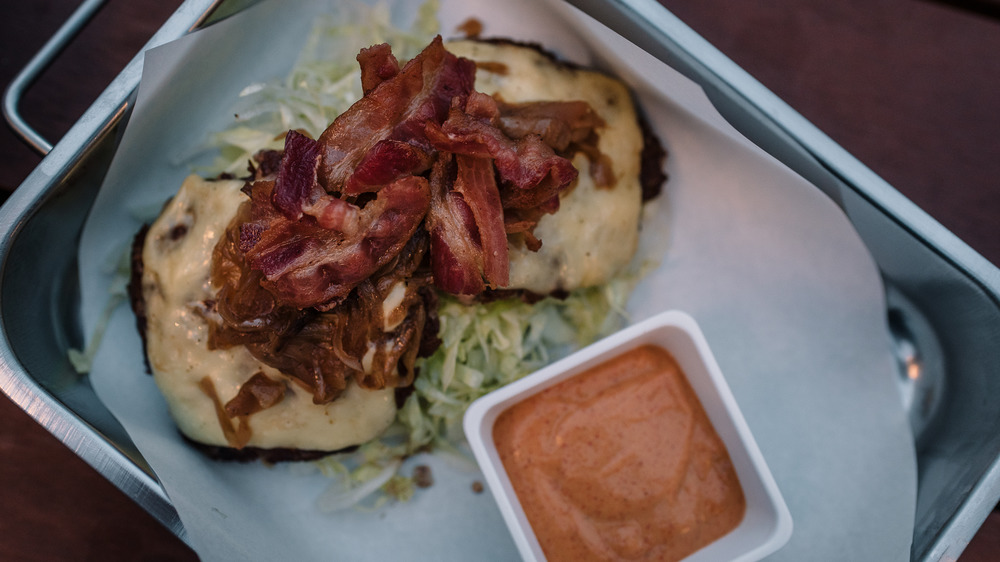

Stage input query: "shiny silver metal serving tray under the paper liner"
[{"left": 0, "top": 0, "right": 1000, "bottom": 561}]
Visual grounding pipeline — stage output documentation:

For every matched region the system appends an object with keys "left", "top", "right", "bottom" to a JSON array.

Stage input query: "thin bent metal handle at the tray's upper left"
[{"left": 3, "top": 0, "right": 106, "bottom": 156}]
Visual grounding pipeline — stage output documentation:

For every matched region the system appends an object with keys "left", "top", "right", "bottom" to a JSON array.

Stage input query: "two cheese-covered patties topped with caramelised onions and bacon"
[{"left": 130, "top": 38, "right": 664, "bottom": 461}]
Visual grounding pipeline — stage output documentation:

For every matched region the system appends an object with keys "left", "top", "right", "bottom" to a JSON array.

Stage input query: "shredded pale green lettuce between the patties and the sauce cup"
[{"left": 397, "top": 276, "right": 633, "bottom": 453}]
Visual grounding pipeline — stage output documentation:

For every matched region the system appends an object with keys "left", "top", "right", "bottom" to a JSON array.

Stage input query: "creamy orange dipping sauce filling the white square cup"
[{"left": 493, "top": 345, "right": 746, "bottom": 561}]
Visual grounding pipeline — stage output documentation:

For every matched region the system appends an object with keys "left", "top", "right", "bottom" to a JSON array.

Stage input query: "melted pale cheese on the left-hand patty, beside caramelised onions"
[{"left": 142, "top": 176, "right": 396, "bottom": 451}]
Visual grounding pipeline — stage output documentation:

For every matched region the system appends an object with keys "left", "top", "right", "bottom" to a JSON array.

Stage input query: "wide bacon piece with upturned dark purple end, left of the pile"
[{"left": 230, "top": 125, "right": 430, "bottom": 310}]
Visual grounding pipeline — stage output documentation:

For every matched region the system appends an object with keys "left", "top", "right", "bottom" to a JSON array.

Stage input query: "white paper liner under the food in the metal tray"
[{"left": 80, "top": 0, "right": 916, "bottom": 560}]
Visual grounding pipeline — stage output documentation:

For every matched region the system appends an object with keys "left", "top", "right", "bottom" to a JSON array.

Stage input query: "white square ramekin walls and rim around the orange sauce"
[{"left": 464, "top": 311, "right": 792, "bottom": 562}]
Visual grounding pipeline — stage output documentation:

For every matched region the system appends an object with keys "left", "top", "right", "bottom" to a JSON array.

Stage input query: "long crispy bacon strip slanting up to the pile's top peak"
[{"left": 319, "top": 36, "right": 476, "bottom": 195}]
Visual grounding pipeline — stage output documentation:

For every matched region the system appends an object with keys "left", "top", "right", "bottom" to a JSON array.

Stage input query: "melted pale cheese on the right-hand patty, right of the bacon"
[{"left": 447, "top": 41, "right": 642, "bottom": 294}]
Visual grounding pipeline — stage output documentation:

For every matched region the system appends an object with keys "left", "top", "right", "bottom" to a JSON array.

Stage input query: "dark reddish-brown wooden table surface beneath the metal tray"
[{"left": 0, "top": 0, "right": 1000, "bottom": 562}]
